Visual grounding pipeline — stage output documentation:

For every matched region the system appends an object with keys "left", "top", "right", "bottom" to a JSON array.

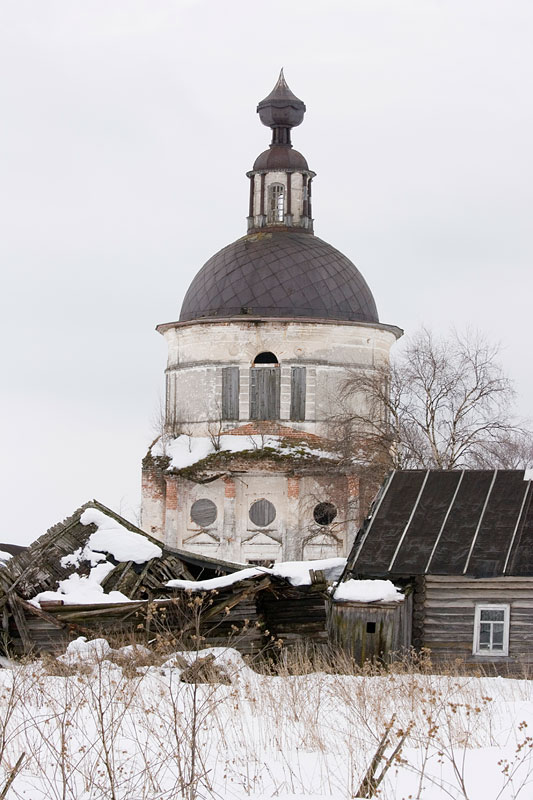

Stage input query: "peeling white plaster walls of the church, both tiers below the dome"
[{"left": 142, "top": 312, "right": 401, "bottom": 563}]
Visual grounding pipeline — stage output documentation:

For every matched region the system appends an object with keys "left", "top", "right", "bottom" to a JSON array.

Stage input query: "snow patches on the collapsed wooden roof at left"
[{"left": 30, "top": 508, "right": 163, "bottom": 605}]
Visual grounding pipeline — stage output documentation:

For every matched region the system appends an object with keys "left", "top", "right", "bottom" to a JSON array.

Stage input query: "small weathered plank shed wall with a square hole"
[{"left": 328, "top": 595, "right": 412, "bottom": 664}]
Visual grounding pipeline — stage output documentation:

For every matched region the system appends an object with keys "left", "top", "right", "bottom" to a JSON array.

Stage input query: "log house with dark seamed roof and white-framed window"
[{"left": 334, "top": 470, "right": 533, "bottom": 672}]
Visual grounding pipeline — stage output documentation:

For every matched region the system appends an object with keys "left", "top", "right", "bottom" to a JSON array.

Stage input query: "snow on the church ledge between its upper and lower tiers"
[{"left": 152, "top": 434, "right": 338, "bottom": 469}]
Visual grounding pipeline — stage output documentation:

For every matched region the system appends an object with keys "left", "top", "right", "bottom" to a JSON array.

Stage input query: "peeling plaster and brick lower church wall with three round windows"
[{"left": 143, "top": 462, "right": 360, "bottom": 563}]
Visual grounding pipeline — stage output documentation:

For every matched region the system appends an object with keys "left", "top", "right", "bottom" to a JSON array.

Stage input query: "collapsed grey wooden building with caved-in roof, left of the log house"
[{"left": 0, "top": 500, "right": 327, "bottom": 655}]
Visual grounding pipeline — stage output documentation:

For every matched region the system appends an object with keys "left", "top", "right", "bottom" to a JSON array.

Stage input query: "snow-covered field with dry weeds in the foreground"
[{"left": 0, "top": 640, "right": 533, "bottom": 800}]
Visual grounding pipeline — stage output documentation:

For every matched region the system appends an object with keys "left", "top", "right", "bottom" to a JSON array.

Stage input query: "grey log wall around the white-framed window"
[{"left": 422, "top": 575, "right": 533, "bottom": 666}]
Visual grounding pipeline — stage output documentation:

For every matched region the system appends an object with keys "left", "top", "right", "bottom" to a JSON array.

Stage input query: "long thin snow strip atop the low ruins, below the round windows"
[{"left": 166, "top": 558, "right": 346, "bottom": 592}]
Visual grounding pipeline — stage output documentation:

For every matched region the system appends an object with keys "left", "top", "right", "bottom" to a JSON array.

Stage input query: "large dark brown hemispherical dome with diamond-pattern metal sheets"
[{"left": 180, "top": 231, "right": 379, "bottom": 322}]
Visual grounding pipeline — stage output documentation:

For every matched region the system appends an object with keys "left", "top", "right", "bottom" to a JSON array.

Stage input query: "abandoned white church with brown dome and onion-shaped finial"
[{"left": 141, "top": 71, "right": 402, "bottom": 565}]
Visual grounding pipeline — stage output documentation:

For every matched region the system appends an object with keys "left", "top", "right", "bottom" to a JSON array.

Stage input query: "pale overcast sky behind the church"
[{"left": 0, "top": 0, "right": 533, "bottom": 543}]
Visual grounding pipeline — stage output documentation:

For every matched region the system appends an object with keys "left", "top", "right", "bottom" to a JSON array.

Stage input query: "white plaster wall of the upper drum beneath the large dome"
[{"left": 158, "top": 319, "right": 401, "bottom": 437}]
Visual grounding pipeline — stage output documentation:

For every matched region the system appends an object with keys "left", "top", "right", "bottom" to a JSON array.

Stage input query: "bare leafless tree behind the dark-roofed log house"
[{"left": 335, "top": 328, "right": 533, "bottom": 469}]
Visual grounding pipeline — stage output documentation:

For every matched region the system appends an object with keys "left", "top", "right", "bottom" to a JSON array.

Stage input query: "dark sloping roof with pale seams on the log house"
[{"left": 347, "top": 470, "right": 533, "bottom": 578}]
